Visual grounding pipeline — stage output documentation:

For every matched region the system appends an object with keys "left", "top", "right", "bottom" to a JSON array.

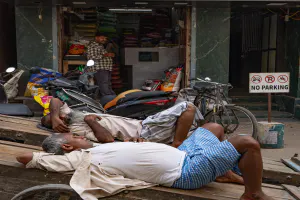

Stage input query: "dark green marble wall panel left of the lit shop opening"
[{"left": 15, "top": 7, "right": 53, "bottom": 68}]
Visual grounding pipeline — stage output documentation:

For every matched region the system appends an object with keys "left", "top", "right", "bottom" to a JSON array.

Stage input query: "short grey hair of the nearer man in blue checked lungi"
[{"left": 42, "top": 133, "right": 68, "bottom": 155}]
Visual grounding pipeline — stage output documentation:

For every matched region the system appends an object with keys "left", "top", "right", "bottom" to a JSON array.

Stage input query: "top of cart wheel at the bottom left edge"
[{"left": 11, "top": 184, "right": 81, "bottom": 200}]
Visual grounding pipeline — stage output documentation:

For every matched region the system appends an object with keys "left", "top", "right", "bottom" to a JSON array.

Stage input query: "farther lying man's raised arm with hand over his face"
[{"left": 49, "top": 98, "right": 69, "bottom": 133}]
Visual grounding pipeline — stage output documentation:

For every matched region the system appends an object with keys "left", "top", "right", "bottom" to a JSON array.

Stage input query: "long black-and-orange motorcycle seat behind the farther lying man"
[{"left": 104, "top": 89, "right": 171, "bottom": 109}]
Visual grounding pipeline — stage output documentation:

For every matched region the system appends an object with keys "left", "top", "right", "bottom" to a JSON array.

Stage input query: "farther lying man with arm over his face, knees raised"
[{"left": 41, "top": 98, "right": 218, "bottom": 147}]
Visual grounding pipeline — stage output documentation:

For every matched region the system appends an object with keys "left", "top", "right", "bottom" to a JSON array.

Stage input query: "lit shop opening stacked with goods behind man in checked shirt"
[{"left": 58, "top": 2, "right": 186, "bottom": 93}]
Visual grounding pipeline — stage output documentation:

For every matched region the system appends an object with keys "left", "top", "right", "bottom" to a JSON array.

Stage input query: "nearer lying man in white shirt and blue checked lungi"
[{"left": 17, "top": 125, "right": 273, "bottom": 200}]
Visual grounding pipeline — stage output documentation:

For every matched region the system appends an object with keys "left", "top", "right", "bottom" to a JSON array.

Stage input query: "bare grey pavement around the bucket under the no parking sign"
[{"left": 258, "top": 118, "right": 300, "bottom": 160}]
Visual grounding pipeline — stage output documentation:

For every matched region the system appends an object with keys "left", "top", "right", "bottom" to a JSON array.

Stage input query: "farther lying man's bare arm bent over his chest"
[{"left": 84, "top": 115, "right": 115, "bottom": 143}]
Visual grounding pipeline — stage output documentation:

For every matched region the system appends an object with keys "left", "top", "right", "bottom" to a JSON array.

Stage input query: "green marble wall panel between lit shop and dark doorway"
[{"left": 196, "top": 5, "right": 230, "bottom": 83}]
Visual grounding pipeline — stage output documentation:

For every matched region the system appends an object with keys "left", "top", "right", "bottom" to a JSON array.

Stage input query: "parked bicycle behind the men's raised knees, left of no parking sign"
[{"left": 193, "top": 78, "right": 258, "bottom": 139}]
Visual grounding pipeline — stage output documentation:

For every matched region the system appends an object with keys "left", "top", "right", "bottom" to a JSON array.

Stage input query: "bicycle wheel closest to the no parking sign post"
[{"left": 204, "top": 105, "right": 257, "bottom": 139}]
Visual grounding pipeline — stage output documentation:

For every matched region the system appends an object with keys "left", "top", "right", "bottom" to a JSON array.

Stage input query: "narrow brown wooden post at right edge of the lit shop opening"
[{"left": 184, "top": 7, "right": 192, "bottom": 87}]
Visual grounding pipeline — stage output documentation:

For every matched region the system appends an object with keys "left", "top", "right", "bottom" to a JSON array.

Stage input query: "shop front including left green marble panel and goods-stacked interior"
[{"left": 12, "top": 0, "right": 191, "bottom": 93}]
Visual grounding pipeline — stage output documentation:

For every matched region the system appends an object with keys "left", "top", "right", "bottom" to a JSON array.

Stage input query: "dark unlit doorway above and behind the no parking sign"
[{"left": 229, "top": 5, "right": 284, "bottom": 96}]
